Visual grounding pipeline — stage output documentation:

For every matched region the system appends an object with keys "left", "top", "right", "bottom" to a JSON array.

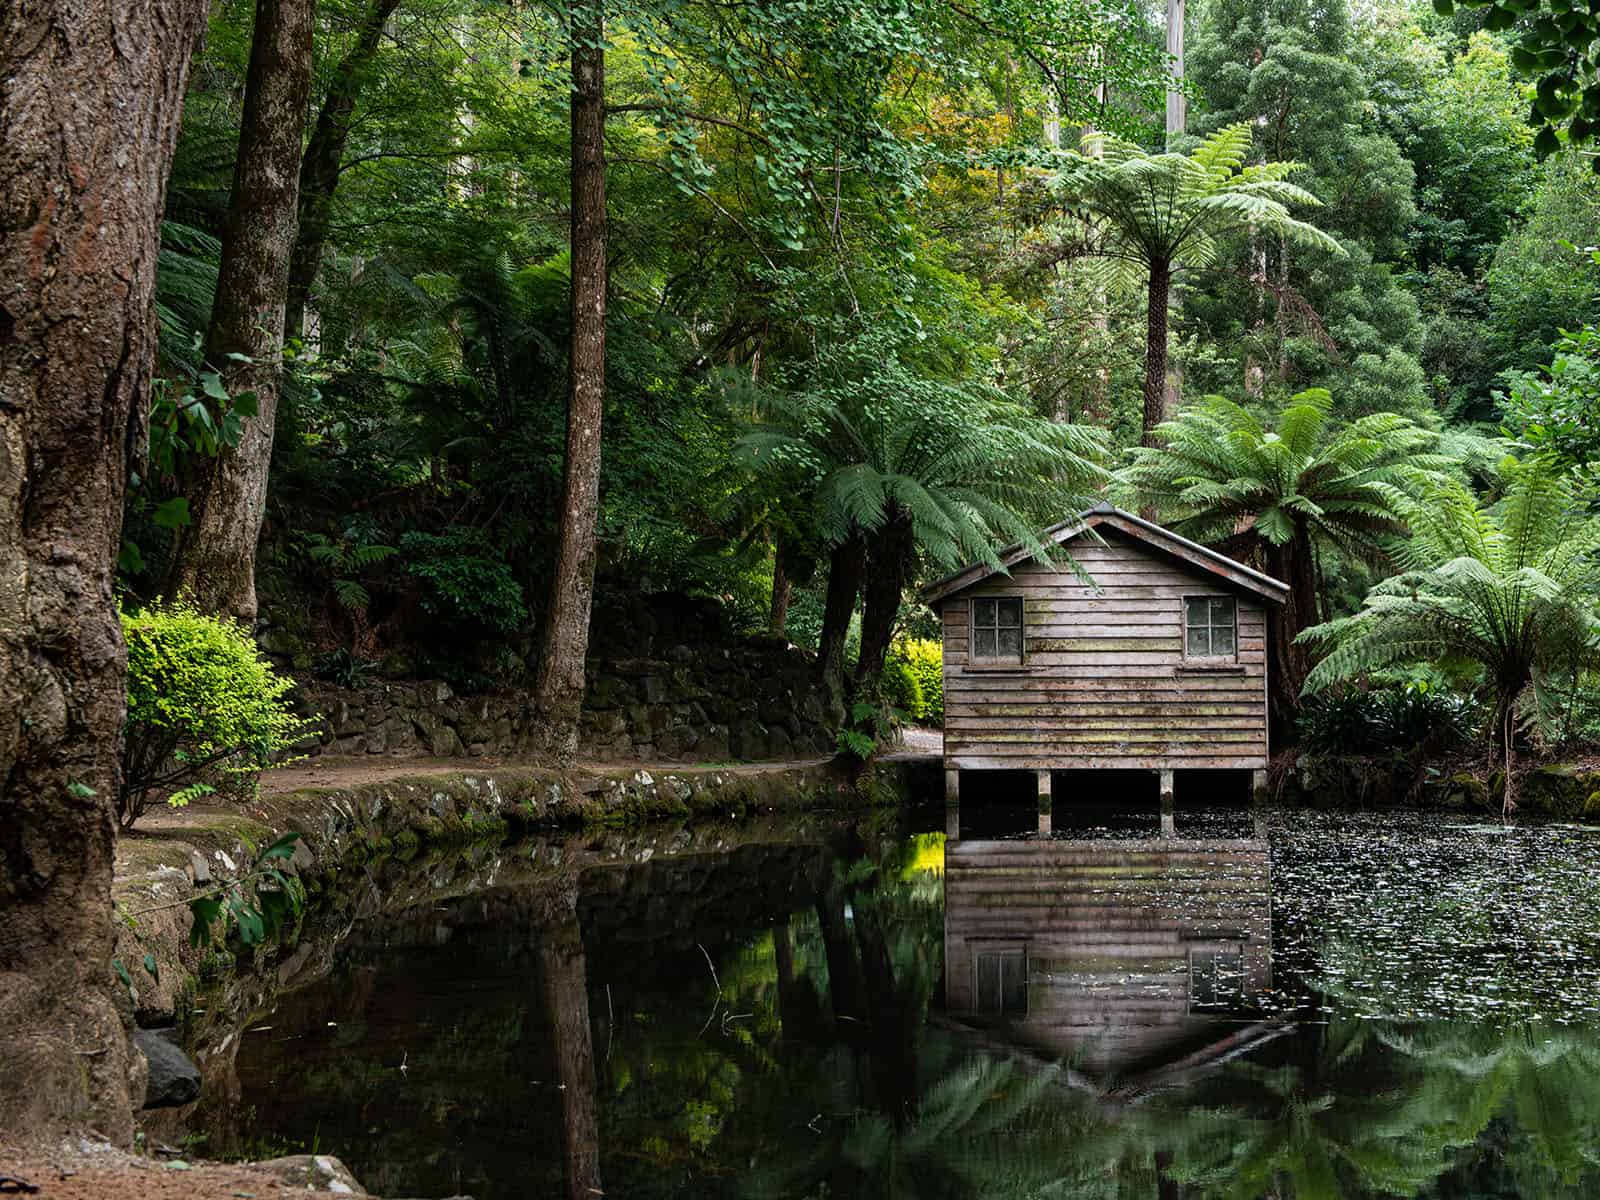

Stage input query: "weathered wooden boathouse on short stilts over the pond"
[{"left": 923, "top": 504, "right": 1288, "bottom": 827}]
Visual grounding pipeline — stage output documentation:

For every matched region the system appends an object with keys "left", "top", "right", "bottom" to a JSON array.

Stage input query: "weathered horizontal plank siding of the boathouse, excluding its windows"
[{"left": 941, "top": 533, "right": 1267, "bottom": 770}]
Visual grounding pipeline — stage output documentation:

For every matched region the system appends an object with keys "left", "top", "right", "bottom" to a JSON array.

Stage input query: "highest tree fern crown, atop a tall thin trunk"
[{"left": 1053, "top": 122, "right": 1344, "bottom": 286}]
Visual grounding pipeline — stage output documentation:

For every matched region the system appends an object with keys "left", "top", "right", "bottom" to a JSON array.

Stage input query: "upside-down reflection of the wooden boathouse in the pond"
[{"left": 944, "top": 838, "right": 1272, "bottom": 1080}]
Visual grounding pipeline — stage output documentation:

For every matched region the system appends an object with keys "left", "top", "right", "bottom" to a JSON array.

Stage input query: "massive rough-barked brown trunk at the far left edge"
[{"left": 0, "top": 0, "right": 206, "bottom": 1142}]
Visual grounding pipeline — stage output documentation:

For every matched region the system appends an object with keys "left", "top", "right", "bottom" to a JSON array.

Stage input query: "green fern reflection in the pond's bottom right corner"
[{"left": 1157, "top": 1018, "right": 1600, "bottom": 1200}]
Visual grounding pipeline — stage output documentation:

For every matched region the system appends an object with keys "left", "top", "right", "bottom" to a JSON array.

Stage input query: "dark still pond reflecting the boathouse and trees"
[{"left": 198, "top": 797, "right": 1600, "bottom": 1200}]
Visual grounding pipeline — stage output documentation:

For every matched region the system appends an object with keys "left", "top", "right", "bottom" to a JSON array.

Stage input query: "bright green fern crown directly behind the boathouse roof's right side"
[{"left": 1117, "top": 389, "right": 1453, "bottom": 558}]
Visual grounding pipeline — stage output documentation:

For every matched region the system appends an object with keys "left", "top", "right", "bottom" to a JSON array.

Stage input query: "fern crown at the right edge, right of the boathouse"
[{"left": 1306, "top": 464, "right": 1600, "bottom": 712}]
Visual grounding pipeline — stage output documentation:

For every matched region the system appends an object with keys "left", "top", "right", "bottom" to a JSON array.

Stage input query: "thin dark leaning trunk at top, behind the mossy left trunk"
[{"left": 283, "top": 0, "right": 400, "bottom": 338}]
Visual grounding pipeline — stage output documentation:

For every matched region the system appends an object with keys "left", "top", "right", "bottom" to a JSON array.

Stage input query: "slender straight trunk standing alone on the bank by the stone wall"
[{"left": 533, "top": 0, "right": 606, "bottom": 763}]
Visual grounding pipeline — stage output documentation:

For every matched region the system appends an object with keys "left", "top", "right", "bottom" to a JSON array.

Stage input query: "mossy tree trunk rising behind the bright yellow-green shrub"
[{"left": 163, "top": 0, "right": 315, "bottom": 624}]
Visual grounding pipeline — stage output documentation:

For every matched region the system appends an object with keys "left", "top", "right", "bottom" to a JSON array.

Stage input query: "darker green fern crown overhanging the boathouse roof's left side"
[{"left": 738, "top": 336, "right": 1107, "bottom": 568}]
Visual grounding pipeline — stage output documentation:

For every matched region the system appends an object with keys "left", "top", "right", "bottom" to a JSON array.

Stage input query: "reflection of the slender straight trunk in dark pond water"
[{"left": 539, "top": 915, "right": 603, "bottom": 1200}]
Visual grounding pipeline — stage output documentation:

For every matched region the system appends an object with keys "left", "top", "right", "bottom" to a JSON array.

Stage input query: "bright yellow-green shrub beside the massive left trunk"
[{"left": 117, "top": 602, "right": 317, "bottom": 829}]
